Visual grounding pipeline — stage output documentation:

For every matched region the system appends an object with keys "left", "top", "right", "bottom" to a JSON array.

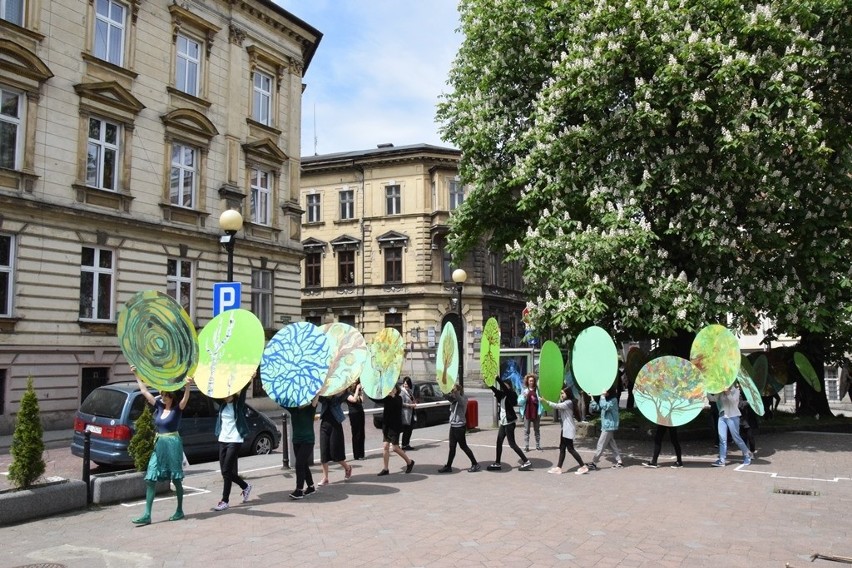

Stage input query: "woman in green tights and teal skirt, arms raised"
[{"left": 130, "top": 366, "right": 192, "bottom": 526}]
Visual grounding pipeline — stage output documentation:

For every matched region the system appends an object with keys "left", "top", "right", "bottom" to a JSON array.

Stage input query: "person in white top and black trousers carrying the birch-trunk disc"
[{"left": 213, "top": 386, "right": 251, "bottom": 511}]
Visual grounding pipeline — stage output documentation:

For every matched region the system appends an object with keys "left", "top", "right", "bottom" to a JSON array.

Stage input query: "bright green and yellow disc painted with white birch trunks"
[{"left": 194, "top": 309, "right": 266, "bottom": 398}]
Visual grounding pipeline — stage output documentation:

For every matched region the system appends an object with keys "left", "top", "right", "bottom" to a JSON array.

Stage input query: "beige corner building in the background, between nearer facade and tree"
[{"left": 300, "top": 144, "right": 525, "bottom": 384}]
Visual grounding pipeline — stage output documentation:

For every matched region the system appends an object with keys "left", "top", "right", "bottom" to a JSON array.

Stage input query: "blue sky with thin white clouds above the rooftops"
[{"left": 275, "top": 0, "right": 461, "bottom": 156}]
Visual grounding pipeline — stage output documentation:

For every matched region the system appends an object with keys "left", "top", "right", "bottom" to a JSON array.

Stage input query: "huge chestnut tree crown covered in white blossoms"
[{"left": 438, "top": 0, "right": 852, "bottom": 355}]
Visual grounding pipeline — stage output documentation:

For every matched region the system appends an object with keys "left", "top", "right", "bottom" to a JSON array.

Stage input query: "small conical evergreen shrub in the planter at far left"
[{"left": 9, "top": 377, "right": 45, "bottom": 488}]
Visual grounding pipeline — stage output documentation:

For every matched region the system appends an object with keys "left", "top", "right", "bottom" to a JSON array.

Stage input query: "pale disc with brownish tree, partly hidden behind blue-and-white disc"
[{"left": 320, "top": 321, "right": 370, "bottom": 396}]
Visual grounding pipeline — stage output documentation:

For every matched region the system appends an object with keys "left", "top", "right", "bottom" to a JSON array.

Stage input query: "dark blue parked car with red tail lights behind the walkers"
[{"left": 71, "top": 382, "right": 281, "bottom": 466}]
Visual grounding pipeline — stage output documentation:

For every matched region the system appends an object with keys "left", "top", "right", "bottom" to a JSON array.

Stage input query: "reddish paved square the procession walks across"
[{"left": 0, "top": 422, "right": 852, "bottom": 568}]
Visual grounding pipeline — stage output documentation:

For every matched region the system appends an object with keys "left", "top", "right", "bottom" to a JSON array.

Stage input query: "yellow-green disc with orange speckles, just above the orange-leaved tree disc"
[{"left": 689, "top": 324, "right": 740, "bottom": 394}]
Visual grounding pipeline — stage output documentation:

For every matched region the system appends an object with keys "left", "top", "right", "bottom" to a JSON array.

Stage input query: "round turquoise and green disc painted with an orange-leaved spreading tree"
[{"left": 633, "top": 355, "right": 707, "bottom": 426}]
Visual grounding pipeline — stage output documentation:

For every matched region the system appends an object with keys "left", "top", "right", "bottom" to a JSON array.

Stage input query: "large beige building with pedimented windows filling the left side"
[{"left": 0, "top": 0, "right": 321, "bottom": 434}]
